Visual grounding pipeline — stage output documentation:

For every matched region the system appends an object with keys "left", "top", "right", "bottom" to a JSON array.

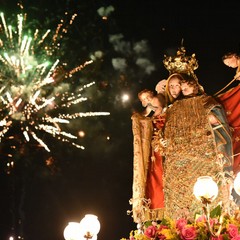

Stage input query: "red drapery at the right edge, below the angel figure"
[{"left": 217, "top": 85, "right": 240, "bottom": 174}]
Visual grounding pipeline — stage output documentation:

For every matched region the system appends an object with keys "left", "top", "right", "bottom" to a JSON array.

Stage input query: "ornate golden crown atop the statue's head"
[{"left": 163, "top": 46, "right": 198, "bottom": 75}]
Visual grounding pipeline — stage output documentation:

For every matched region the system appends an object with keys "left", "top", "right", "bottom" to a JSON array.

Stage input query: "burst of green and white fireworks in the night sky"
[{"left": 0, "top": 13, "right": 109, "bottom": 151}]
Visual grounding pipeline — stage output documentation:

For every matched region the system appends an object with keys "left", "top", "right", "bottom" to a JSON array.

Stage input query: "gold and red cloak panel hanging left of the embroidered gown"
[{"left": 131, "top": 114, "right": 164, "bottom": 223}]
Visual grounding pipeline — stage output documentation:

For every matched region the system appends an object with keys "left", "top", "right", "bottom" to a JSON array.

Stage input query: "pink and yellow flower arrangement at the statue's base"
[{"left": 121, "top": 207, "right": 240, "bottom": 240}]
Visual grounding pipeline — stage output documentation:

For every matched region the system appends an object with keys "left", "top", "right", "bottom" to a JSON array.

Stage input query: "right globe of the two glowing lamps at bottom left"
[{"left": 80, "top": 214, "right": 100, "bottom": 240}]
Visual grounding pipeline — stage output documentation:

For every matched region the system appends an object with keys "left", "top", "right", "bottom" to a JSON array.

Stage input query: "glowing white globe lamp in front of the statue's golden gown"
[{"left": 193, "top": 176, "right": 218, "bottom": 202}]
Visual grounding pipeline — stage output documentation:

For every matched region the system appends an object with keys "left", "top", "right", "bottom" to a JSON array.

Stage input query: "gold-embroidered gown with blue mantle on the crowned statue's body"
[{"left": 163, "top": 95, "right": 232, "bottom": 218}]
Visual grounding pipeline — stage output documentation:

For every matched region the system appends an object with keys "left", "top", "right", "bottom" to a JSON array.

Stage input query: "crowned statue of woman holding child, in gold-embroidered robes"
[{"left": 130, "top": 46, "right": 234, "bottom": 223}]
